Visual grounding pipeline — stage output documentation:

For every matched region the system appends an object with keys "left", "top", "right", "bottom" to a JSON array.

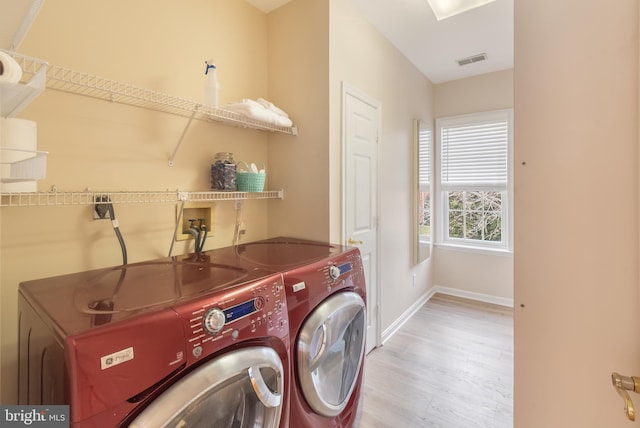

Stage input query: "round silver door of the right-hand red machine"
[{"left": 296, "top": 292, "right": 366, "bottom": 416}]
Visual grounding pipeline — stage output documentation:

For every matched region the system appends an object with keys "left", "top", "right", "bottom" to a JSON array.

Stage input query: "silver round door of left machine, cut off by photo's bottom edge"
[{"left": 129, "top": 347, "right": 284, "bottom": 428}]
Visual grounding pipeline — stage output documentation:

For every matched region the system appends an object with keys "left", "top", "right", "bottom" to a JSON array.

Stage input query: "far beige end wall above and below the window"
[{"left": 433, "top": 70, "right": 517, "bottom": 305}]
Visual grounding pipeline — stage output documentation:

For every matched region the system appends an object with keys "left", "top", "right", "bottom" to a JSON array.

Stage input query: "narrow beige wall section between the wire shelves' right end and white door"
[{"left": 268, "top": 0, "right": 330, "bottom": 241}]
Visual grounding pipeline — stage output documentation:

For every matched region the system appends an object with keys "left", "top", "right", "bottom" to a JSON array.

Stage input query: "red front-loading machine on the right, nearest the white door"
[{"left": 212, "top": 238, "right": 366, "bottom": 428}]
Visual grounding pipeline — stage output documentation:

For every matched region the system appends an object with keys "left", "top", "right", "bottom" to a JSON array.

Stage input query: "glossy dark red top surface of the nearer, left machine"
[{"left": 20, "top": 254, "right": 272, "bottom": 336}]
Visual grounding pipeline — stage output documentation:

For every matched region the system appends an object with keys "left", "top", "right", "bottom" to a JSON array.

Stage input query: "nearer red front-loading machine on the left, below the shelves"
[{"left": 18, "top": 255, "right": 290, "bottom": 428}]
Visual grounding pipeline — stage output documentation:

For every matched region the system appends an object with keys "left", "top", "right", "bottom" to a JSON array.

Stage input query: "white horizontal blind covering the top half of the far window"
[{"left": 439, "top": 115, "right": 509, "bottom": 190}]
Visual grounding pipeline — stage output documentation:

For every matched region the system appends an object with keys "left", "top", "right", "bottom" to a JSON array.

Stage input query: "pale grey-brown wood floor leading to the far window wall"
[{"left": 359, "top": 294, "right": 513, "bottom": 428}]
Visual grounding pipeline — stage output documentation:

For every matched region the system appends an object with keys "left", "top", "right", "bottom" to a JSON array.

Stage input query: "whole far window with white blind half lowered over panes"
[{"left": 436, "top": 110, "right": 512, "bottom": 249}]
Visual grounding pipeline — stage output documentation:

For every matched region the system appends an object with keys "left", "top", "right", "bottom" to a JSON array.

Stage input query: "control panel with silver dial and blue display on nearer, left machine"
[{"left": 175, "top": 274, "right": 289, "bottom": 361}]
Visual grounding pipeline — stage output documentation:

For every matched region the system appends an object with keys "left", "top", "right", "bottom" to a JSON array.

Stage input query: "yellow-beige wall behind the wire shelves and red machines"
[{"left": 0, "top": 0, "right": 280, "bottom": 403}]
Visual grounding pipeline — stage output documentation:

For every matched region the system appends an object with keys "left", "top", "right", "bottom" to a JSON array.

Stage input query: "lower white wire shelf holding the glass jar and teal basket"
[{"left": 0, "top": 190, "right": 284, "bottom": 207}]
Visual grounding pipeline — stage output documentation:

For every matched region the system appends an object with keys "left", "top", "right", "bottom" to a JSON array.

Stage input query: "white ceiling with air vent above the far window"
[{"left": 351, "top": 0, "right": 514, "bottom": 83}]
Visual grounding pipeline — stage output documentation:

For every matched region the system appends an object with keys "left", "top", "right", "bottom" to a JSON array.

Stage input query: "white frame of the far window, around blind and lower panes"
[{"left": 434, "top": 109, "right": 513, "bottom": 252}]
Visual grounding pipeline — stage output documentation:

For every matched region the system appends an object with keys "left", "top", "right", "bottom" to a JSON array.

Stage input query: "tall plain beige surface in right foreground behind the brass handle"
[{"left": 514, "top": 0, "right": 640, "bottom": 428}]
